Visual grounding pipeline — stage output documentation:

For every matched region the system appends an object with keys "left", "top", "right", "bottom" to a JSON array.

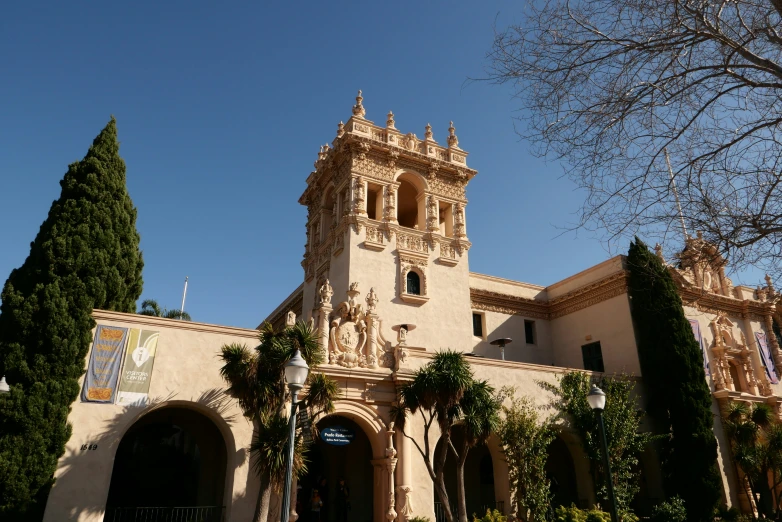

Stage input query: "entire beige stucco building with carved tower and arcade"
[{"left": 46, "top": 93, "right": 782, "bottom": 522}]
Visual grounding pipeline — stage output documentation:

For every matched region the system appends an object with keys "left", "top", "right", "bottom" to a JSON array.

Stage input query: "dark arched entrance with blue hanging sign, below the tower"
[{"left": 296, "top": 415, "right": 374, "bottom": 522}]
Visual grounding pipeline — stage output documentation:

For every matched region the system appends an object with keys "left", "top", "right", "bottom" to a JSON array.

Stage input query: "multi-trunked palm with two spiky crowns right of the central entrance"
[{"left": 392, "top": 350, "right": 499, "bottom": 522}]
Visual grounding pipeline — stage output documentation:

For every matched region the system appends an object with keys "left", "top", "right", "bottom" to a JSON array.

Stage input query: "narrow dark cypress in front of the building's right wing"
[{"left": 627, "top": 238, "right": 722, "bottom": 522}]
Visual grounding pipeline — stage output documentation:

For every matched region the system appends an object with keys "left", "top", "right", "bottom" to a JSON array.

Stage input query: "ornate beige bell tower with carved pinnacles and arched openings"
[{"left": 299, "top": 91, "right": 477, "bottom": 356}]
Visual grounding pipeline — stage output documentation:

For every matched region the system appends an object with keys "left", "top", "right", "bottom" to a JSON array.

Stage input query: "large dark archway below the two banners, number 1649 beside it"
[{"left": 105, "top": 407, "right": 227, "bottom": 522}]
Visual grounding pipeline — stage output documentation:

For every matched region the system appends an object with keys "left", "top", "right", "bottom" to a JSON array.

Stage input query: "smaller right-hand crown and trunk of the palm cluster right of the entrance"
[{"left": 455, "top": 381, "right": 502, "bottom": 522}]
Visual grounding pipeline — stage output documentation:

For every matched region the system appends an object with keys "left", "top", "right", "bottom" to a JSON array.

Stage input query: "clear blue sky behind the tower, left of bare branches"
[{"left": 0, "top": 0, "right": 758, "bottom": 327}]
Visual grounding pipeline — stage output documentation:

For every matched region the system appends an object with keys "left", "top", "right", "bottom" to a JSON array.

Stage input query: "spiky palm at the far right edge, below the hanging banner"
[{"left": 724, "top": 402, "right": 782, "bottom": 520}]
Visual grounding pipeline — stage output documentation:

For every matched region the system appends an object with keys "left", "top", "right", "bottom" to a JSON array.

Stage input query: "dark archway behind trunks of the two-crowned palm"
[{"left": 434, "top": 429, "right": 504, "bottom": 521}]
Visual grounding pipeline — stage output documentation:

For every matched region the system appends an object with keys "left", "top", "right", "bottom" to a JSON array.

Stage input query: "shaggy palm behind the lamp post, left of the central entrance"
[{"left": 220, "top": 322, "right": 339, "bottom": 522}]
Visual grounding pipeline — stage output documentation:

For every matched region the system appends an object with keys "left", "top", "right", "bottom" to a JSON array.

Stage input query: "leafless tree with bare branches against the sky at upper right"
[{"left": 488, "top": 0, "right": 782, "bottom": 269}]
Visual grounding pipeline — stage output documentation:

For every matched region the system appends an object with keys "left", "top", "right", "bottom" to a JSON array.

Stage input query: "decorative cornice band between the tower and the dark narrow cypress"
[{"left": 470, "top": 271, "right": 627, "bottom": 319}]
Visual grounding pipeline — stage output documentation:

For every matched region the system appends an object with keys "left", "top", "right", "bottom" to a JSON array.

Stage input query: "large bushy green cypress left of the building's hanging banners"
[{"left": 0, "top": 117, "right": 144, "bottom": 520}]
